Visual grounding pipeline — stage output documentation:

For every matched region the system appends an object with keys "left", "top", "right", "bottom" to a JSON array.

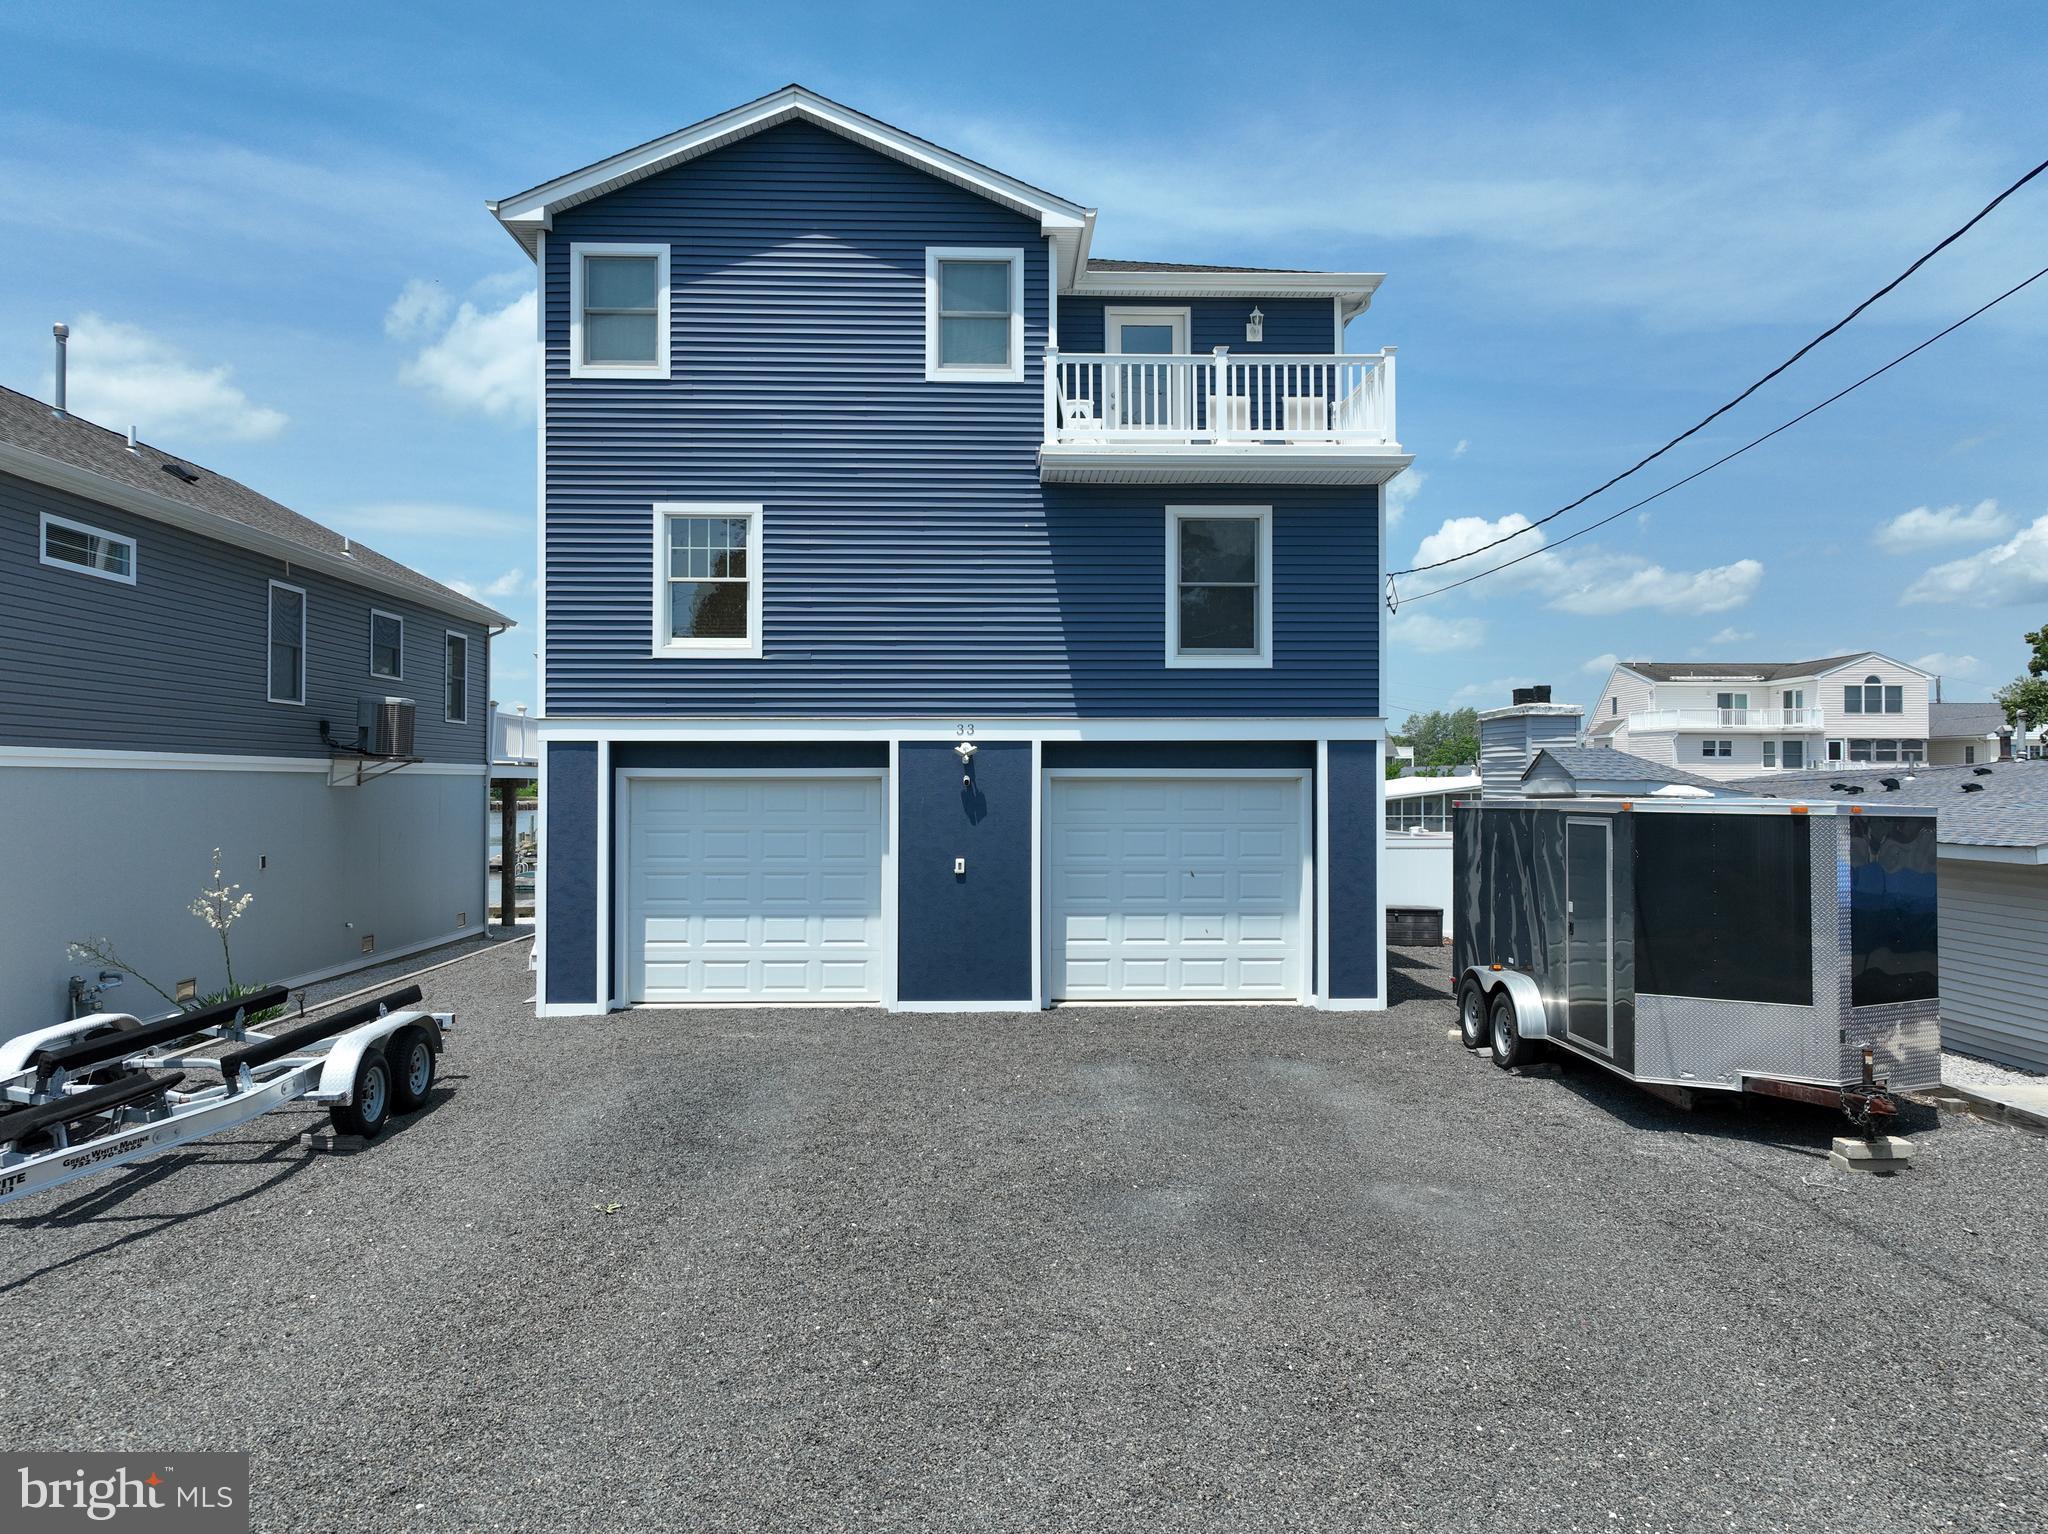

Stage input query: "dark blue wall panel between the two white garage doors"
[{"left": 897, "top": 741, "right": 1032, "bottom": 1002}]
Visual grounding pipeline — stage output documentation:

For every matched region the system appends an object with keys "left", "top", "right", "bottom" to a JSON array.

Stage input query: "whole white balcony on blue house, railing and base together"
[{"left": 1038, "top": 346, "right": 1413, "bottom": 485}]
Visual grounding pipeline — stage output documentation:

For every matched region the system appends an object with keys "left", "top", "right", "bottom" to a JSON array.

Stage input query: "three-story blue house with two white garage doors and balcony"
[{"left": 492, "top": 86, "right": 1411, "bottom": 1014}]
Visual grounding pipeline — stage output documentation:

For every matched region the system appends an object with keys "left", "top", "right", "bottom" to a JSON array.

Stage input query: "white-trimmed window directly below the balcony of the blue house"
[{"left": 1165, "top": 506, "right": 1274, "bottom": 666}]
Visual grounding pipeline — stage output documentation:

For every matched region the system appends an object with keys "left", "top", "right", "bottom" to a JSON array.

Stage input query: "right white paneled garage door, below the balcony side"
[{"left": 1047, "top": 778, "right": 1305, "bottom": 999}]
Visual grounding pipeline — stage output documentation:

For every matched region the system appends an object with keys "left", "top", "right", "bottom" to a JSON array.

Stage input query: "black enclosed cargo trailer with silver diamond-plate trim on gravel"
[{"left": 1452, "top": 799, "right": 1942, "bottom": 1122}]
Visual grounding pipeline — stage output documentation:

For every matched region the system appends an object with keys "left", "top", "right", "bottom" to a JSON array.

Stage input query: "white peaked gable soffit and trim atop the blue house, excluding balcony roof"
[{"left": 485, "top": 86, "right": 1096, "bottom": 281}]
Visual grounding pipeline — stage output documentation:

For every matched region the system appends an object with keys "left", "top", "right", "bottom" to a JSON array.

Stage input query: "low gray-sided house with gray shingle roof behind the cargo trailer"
[{"left": 1733, "top": 761, "right": 2048, "bottom": 1071}]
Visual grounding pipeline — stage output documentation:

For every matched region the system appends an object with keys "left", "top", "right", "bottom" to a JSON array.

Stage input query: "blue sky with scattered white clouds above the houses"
[{"left": 0, "top": 0, "right": 2048, "bottom": 719}]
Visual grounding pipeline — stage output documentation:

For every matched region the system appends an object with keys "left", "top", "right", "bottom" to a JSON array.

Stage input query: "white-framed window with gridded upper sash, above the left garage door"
[{"left": 653, "top": 502, "right": 762, "bottom": 657}]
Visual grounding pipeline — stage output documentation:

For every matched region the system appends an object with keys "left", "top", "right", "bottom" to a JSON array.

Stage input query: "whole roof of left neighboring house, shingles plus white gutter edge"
[{"left": 0, "top": 385, "right": 512, "bottom": 629}]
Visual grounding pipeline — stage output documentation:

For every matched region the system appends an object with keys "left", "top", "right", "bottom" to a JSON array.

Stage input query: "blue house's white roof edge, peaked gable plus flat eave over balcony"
[{"left": 485, "top": 84, "right": 1384, "bottom": 319}]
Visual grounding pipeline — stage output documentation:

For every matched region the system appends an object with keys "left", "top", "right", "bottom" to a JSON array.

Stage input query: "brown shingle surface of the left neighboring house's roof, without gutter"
[{"left": 0, "top": 385, "right": 512, "bottom": 625}]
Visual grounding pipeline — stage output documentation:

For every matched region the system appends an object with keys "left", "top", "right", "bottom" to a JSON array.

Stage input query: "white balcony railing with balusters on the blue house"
[{"left": 1044, "top": 346, "right": 1399, "bottom": 446}]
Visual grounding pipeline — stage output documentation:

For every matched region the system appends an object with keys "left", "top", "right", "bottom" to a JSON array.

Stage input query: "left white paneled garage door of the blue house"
[{"left": 621, "top": 776, "right": 885, "bottom": 1002}]
